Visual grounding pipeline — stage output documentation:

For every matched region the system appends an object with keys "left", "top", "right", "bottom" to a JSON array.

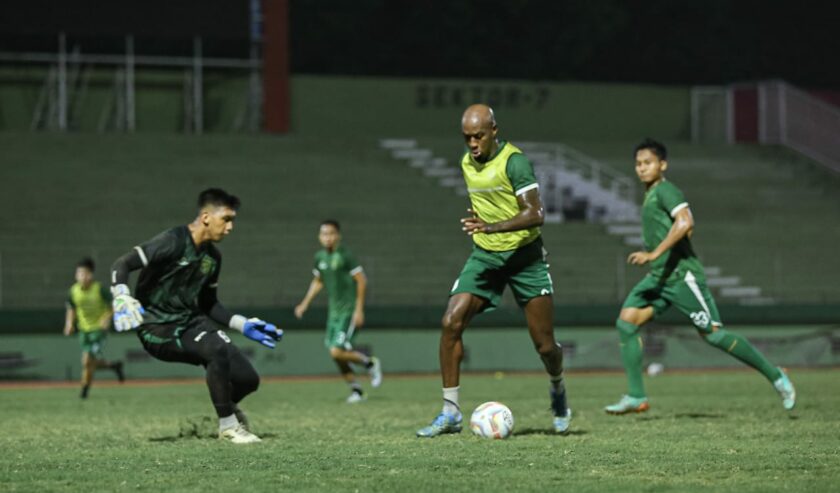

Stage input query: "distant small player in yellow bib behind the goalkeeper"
[{"left": 64, "top": 258, "right": 125, "bottom": 399}]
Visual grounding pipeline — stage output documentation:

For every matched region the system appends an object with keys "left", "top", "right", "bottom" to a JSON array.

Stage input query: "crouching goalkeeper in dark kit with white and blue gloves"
[{"left": 111, "top": 188, "right": 283, "bottom": 443}]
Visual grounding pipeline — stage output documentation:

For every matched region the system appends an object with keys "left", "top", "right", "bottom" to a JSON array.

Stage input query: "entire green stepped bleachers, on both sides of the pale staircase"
[{"left": 0, "top": 133, "right": 840, "bottom": 309}]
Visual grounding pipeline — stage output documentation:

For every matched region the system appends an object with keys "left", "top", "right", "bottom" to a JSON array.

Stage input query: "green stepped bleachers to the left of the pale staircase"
[{"left": 0, "top": 134, "right": 467, "bottom": 308}]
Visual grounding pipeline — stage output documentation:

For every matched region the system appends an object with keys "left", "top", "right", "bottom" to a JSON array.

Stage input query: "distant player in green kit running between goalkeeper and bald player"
[{"left": 295, "top": 219, "right": 382, "bottom": 404}]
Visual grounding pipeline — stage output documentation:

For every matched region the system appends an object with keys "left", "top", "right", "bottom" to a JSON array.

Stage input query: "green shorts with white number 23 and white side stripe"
[{"left": 622, "top": 271, "right": 723, "bottom": 332}]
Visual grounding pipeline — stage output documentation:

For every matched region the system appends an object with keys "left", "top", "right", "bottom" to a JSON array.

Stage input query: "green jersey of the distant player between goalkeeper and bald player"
[{"left": 312, "top": 245, "right": 362, "bottom": 313}]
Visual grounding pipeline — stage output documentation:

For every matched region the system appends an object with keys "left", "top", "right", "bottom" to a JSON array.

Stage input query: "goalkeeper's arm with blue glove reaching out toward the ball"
[{"left": 198, "top": 257, "right": 283, "bottom": 349}]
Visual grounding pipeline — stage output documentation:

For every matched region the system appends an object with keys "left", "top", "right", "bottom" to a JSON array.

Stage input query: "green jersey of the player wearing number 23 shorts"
[{"left": 642, "top": 179, "right": 706, "bottom": 281}]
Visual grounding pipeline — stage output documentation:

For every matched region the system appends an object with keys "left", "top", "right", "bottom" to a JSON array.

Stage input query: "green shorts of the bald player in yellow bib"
[{"left": 449, "top": 238, "right": 554, "bottom": 311}]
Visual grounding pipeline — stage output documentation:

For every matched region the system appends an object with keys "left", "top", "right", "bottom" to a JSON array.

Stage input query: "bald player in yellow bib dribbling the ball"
[{"left": 417, "top": 104, "right": 572, "bottom": 437}]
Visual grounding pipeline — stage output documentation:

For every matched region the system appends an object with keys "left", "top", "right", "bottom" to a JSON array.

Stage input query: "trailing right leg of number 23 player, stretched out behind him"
[{"left": 673, "top": 272, "right": 796, "bottom": 410}]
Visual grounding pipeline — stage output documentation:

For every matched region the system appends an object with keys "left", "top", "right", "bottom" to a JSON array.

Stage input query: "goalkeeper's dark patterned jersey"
[{"left": 134, "top": 226, "right": 222, "bottom": 325}]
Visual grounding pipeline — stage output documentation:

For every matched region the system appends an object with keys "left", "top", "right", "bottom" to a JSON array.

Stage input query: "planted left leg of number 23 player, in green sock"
[{"left": 604, "top": 276, "right": 668, "bottom": 414}]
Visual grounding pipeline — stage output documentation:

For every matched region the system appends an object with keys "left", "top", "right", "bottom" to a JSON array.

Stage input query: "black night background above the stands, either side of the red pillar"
[{"left": 0, "top": 0, "right": 840, "bottom": 89}]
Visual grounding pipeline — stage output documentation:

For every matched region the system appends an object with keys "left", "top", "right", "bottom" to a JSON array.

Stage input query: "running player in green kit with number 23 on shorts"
[{"left": 605, "top": 139, "right": 796, "bottom": 414}]
